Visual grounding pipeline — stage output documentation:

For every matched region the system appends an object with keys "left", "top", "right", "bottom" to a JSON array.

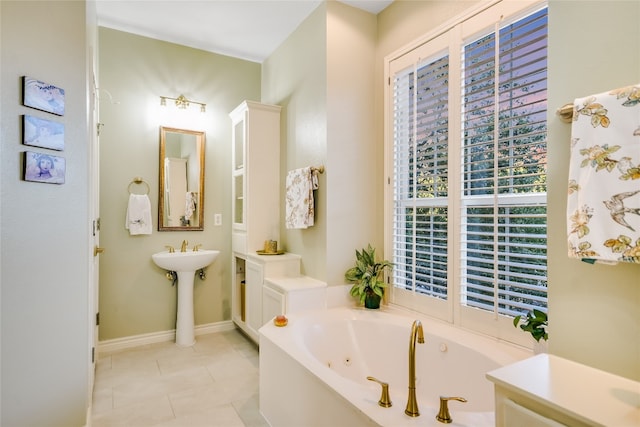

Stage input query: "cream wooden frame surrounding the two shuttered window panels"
[{"left": 384, "top": 0, "right": 547, "bottom": 347}]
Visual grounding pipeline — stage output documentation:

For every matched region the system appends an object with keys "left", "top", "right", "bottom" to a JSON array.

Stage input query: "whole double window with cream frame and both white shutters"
[{"left": 387, "top": 3, "right": 547, "bottom": 348}]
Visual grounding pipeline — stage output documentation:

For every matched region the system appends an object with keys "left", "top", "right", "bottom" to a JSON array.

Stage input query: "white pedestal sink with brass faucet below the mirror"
[{"left": 151, "top": 249, "right": 220, "bottom": 346}]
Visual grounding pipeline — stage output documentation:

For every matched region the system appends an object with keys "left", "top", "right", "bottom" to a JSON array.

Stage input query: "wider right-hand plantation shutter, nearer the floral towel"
[{"left": 460, "top": 8, "right": 547, "bottom": 316}]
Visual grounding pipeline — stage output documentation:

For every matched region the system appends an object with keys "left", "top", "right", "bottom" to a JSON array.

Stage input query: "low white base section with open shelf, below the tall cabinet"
[{"left": 232, "top": 253, "right": 300, "bottom": 343}]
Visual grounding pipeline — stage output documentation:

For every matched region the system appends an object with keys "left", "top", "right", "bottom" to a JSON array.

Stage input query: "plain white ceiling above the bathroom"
[{"left": 96, "top": 0, "right": 393, "bottom": 62}]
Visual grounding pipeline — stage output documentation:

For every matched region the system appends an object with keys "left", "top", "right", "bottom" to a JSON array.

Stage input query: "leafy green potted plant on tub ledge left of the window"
[{"left": 344, "top": 244, "right": 393, "bottom": 308}]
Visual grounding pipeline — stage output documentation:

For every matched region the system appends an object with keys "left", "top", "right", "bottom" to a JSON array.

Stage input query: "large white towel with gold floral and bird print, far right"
[{"left": 567, "top": 84, "right": 640, "bottom": 264}]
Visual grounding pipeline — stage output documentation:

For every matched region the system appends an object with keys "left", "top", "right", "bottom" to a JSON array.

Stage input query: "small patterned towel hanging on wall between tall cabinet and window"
[{"left": 285, "top": 167, "right": 318, "bottom": 229}]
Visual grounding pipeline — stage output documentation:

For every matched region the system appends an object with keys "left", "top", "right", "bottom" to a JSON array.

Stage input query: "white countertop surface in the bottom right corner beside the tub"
[{"left": 487, "top": 354, "right": 640, "bottom": 427}]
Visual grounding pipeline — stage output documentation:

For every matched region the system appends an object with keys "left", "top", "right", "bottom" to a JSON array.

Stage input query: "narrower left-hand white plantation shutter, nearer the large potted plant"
[{"left": 392, "top": 53, "right": 449, "bottom": 299}]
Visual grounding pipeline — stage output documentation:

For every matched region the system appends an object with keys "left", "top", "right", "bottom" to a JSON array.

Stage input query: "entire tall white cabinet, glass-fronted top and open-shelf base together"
[{"left": 229, "top": 101, "right": 282, "bottom": 342}]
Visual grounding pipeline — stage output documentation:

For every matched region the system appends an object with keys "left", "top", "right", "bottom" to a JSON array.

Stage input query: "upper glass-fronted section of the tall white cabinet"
[{"left": 229, "top": 101, "right": 280, "bottom": 254}]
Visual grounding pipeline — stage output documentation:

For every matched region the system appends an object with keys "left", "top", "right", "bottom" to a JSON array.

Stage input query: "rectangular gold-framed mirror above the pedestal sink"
[{"left": 158, "top": 126, "right": 205, "bottom": 231}]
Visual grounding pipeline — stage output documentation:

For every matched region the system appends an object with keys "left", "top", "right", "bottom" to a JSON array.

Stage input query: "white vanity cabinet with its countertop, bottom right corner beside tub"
[{"left": 487, "top": 354, "right": 640, "bottom": 427}]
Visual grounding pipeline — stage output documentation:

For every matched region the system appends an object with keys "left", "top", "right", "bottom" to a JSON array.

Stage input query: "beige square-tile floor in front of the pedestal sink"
[{"left": 92, "top": 330, "right": 268, "bottom": 427}]
